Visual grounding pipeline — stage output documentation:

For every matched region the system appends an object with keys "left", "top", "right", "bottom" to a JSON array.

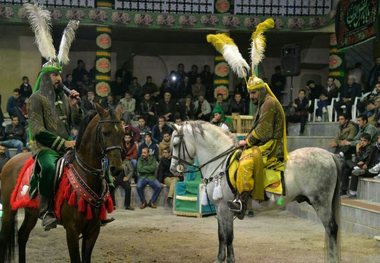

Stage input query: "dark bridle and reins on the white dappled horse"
[{"left": 172, "top": 129, "right": 238, "bottom": 179}]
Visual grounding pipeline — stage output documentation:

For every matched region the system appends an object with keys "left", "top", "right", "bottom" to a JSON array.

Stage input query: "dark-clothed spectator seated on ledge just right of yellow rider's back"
[{"left": 286, "top": 89, "right": 309, "bottom": 135}]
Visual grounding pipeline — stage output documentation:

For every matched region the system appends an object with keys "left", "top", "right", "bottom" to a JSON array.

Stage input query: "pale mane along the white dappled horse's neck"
[{"left": 184, "top": 121, "right": 236, "bottom": 144}]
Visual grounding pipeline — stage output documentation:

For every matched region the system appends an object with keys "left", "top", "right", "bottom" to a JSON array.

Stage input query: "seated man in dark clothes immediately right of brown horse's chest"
[{"left": 110, "top": 160, "right": 135, "bottom": 210}]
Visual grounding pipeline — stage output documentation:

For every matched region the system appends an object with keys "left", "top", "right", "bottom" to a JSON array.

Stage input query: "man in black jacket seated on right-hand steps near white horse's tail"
[{"left": 341, "top": 133, "right": 377, "bottom": 198}]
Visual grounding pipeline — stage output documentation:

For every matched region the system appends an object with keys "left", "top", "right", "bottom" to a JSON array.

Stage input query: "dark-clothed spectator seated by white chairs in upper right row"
[{"left": 334, "top": 76, "right": 362, "bottom": 119}]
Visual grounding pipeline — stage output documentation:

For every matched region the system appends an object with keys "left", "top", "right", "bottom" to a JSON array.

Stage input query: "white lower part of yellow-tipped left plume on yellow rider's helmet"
[{"left": 222, "top": 45, "right": 250, "bottom": 78}]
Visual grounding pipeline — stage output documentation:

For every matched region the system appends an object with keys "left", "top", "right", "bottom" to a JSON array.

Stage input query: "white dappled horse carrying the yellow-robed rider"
[{"left": 171, "top": 121, "right": 340, "bottom": 262}]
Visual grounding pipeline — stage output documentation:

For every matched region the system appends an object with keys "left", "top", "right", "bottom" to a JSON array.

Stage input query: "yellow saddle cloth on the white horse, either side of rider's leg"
[{"left": 227, "top": 149, "right": 285, "bottom": 198}]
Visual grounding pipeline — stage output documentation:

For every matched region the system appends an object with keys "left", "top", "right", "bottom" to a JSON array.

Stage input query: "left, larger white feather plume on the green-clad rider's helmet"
[{"left": 24, "top": 3, "right": 56, "bottom": 60}]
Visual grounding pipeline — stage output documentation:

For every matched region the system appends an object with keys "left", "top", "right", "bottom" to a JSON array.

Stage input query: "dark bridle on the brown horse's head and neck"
[{"left": 74, "top": 120, "right": 123, "bottom": 176}]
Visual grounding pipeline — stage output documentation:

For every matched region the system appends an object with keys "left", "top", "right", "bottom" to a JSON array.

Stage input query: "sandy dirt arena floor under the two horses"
[{"left": 7, "top": 207, "right": 380, "bottom": 263}]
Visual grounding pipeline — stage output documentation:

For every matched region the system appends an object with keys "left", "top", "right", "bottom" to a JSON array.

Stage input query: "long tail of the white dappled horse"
[{"left": 331, "top": 155, "right": 342, "bottom": 262}]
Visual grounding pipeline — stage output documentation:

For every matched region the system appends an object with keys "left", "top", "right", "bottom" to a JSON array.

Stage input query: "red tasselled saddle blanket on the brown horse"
[{"left": 10, "top": 158, "right": 113, "bottom": 220}]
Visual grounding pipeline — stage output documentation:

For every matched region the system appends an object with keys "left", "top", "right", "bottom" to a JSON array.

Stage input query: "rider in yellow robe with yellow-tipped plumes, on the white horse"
[{"left": 207, "top": 19, "right": 288, "bottom": 219}]
